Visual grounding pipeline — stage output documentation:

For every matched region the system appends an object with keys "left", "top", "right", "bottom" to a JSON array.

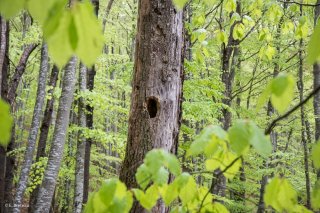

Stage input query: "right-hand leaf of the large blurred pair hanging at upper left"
[{"left": 69, "top": 1, "right": 104, "bottom": 67}]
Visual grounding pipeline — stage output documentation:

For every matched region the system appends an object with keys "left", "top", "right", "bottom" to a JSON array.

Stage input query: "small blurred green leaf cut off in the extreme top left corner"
[{"left": 0, "top": 0, "right": 25, "bottom": 19}]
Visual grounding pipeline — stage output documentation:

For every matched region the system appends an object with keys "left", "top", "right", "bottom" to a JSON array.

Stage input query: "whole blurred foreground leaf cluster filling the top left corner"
[{"left": 0, "top": 0, "right": 104, "bottom": 67}]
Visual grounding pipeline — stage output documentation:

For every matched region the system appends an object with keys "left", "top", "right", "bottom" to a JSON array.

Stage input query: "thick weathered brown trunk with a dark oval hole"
[{"left": 120, "top": 0, "right": 184, "bottom": 212}]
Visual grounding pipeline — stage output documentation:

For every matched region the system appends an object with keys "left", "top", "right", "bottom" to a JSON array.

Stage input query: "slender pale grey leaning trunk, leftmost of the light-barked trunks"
[{"left": 13, "top": 43, "right": 49, "bottom": 213}]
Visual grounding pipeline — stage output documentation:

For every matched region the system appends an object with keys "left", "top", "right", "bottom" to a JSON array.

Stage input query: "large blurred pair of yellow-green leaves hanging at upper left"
[{"left": 44, "top": 2, "right": 103, "bottom": 66}]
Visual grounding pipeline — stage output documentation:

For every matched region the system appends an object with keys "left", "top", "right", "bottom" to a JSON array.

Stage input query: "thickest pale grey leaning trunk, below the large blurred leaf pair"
[{"left": 35, "top": 57, "right": 77, "bottom": 213}]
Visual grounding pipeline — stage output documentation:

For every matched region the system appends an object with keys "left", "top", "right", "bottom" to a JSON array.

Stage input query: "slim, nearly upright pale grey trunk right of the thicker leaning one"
[{"left": 74, "top": 63, "right": 87, "bottom": 213}]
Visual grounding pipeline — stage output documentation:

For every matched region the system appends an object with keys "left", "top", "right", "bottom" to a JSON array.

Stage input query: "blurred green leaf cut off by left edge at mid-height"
[{"left": 0, "top": 99, "right": 13, "bottom": 147}]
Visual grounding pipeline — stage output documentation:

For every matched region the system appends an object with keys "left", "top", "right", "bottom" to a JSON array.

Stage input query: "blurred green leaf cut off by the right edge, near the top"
[{"left": 307, "top": 21, "right": 320, "bottom": 64}]
